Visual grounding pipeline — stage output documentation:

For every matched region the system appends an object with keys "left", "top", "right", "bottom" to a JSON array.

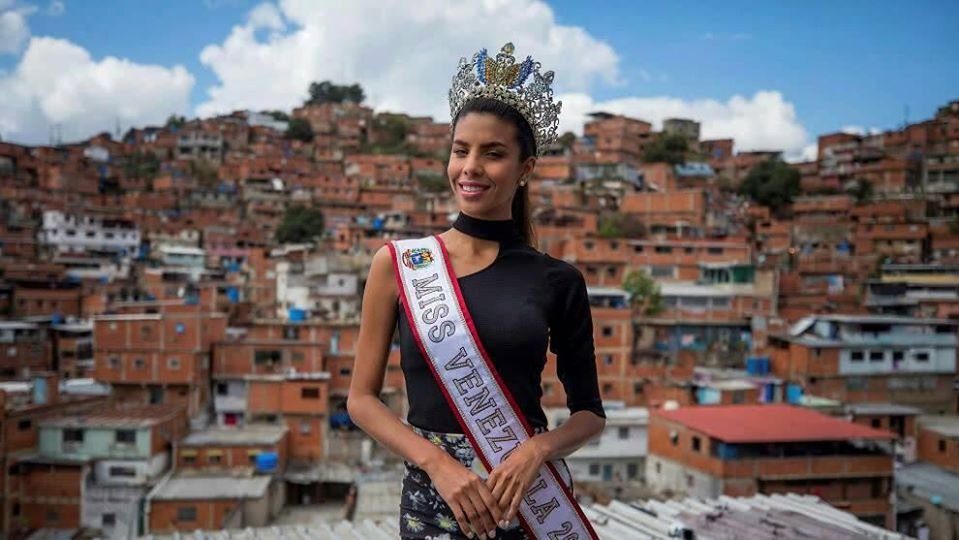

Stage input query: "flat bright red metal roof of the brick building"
[{"left": 654, "top": 404, "right": 896, "bottom": 443}]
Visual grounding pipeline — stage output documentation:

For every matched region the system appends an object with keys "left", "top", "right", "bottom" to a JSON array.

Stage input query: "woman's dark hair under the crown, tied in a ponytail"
[{"left": 453, "top": 98, "right": 536, "bottom": 247}]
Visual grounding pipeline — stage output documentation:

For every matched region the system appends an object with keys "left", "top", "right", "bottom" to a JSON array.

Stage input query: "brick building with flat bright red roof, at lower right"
[{"left": 646, "top": 405, "right": 894, "bottom": 527}]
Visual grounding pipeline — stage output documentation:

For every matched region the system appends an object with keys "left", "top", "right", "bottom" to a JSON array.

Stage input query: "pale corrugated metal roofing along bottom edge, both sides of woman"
[{"left": 135, "top": 494, "right": 906, "bottom": 540}]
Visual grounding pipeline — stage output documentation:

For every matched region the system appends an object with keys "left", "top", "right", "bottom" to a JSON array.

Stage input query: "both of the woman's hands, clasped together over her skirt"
[{"left": 428, "top": 437, "right": 547, "bottom": 540}]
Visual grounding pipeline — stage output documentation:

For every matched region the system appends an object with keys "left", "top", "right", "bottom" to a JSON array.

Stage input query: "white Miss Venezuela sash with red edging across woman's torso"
[{"left": 389, "top": 236, "right": 598, "bottom": 540}]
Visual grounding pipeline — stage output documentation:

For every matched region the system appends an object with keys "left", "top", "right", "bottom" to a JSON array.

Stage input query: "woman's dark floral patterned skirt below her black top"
[{"left": 400, "top": 426, "right": 572, "bottom": 540}]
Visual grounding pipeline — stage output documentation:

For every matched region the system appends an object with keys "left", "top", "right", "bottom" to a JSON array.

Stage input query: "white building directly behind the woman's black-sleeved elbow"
[{"left": 546, "top": 402, "right": 649, "bottom": 482}]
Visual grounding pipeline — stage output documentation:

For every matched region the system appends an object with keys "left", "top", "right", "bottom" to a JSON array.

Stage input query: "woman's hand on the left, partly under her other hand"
[{"left": 426, "top": 453, "right": 503, "bottom": 540}]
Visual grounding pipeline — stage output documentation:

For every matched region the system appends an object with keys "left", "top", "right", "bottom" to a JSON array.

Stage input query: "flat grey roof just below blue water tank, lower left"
[{"left": 147, "top": 476, "right": 273, "bottom": 501}]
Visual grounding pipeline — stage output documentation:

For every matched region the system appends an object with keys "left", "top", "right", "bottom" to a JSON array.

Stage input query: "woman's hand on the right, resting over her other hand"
[{"left": 486, "top": 437, "right": 547, "bottom": 528}]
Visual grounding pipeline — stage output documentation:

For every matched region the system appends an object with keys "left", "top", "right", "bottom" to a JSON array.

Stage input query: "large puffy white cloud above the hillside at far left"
[{"left": 0, "top": 37, "right": 194, "bottom": 143}]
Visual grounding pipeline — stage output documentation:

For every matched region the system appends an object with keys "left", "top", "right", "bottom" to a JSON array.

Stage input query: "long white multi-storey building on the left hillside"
[{"left": 37, "top": 210, "right": 140, "bottom": 255}]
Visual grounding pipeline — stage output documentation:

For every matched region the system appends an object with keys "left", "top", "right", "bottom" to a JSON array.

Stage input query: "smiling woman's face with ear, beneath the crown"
[{"left": 446, "top": 113, "right": 536, "bottom": 220}]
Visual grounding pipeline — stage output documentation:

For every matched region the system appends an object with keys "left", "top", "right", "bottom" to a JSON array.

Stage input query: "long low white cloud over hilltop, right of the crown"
[{"left": 559, "top": 90, "right": 807, "bottom": 156}]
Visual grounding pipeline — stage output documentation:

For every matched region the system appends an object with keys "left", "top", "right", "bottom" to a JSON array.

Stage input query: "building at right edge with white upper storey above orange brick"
[{"left": 769, "top": 315, "right": 959, "bottom": 413}]
